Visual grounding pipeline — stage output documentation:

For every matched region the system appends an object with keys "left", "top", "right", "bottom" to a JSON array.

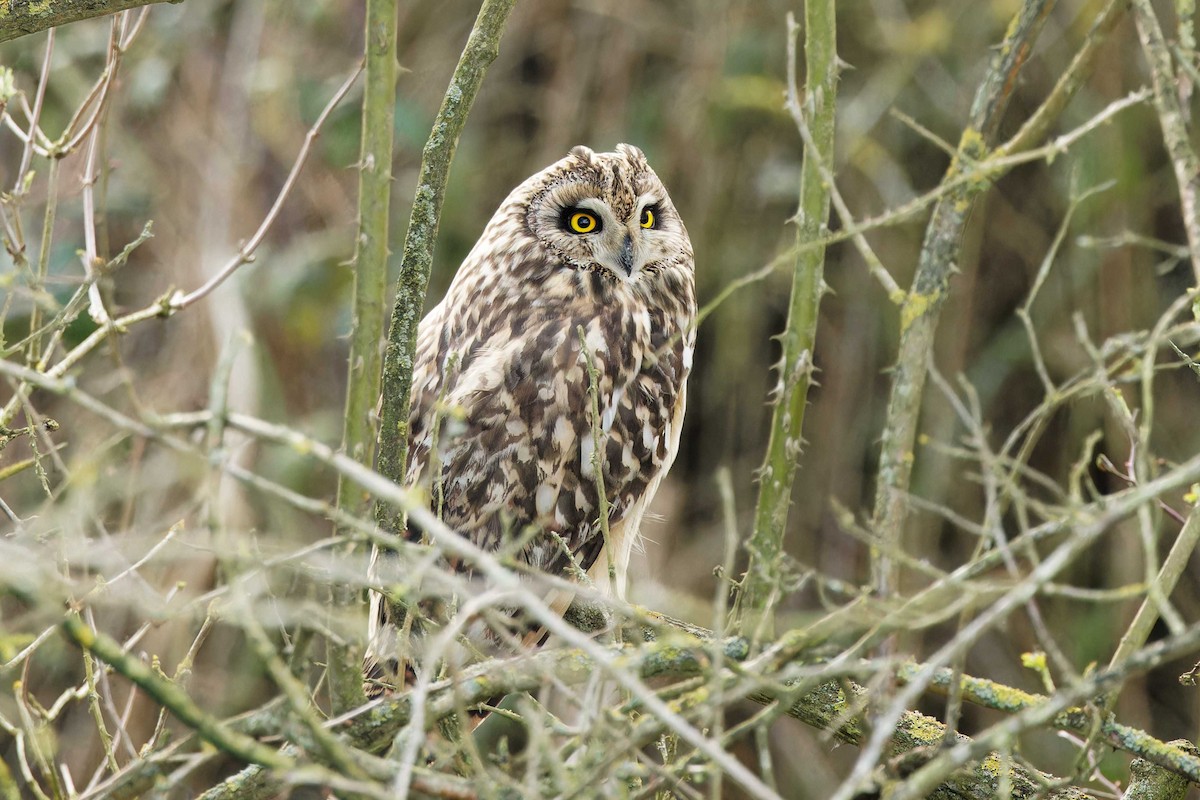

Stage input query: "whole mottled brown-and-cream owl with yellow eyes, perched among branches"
[{"left": 364, "top": 144, "right": 696, "bottom": 696}]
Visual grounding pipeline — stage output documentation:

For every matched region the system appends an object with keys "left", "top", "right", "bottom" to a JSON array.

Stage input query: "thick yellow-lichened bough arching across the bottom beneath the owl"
[{"left": 189, "top": 613, "right": 1200, "bottom": 800}]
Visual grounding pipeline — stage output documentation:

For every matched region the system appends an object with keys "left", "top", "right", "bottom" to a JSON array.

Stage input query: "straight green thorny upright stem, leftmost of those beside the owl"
[{"left": 328, "top": 0, "right": 398, "bottom": 714}]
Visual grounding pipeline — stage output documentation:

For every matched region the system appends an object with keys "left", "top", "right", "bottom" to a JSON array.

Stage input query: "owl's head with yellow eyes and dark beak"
[{"left": 514, "top": 144, "right": 692, "bottom": 284}]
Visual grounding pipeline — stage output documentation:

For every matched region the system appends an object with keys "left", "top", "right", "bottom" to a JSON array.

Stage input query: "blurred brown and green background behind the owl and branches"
[{"left": 0, "top": 0, "right": 1200, "bottom": 798}]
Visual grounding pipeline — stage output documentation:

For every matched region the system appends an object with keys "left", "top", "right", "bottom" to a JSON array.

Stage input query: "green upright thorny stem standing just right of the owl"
[{"left": 740, "top": 0, "right": 838, "bottom": 637}]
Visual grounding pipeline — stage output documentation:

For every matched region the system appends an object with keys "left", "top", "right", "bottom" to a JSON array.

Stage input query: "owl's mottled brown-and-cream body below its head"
[{"left": 408, "top": 251, "right": 695, "bottom": 587}]
